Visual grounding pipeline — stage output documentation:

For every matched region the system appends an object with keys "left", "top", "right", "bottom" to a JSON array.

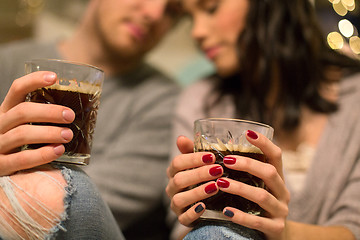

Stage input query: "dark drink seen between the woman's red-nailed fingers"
[{"left": 197, "top": 149, "right": 266, "bottom": 215}]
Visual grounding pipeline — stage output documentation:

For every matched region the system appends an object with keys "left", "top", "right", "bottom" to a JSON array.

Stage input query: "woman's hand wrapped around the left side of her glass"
[{"left": 166, "top": 136, "right": 223, "bottom": 226}]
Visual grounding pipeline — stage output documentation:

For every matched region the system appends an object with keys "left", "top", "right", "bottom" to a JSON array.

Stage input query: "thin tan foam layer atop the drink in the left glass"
[{"left": 45, "top": 80, "right": 101, "bottom": 94}]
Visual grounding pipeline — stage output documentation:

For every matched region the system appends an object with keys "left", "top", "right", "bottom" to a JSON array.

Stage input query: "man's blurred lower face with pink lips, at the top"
[{"left": 94, "top": 0, "right": 173, "bottom": 58}]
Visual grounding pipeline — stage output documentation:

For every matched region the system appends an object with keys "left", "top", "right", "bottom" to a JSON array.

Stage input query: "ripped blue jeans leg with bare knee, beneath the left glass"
[{"left": 0, "top": 165, "right": 124, "bottom": 239}]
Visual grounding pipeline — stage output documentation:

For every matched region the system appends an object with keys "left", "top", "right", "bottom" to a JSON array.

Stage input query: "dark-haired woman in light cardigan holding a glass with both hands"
[{"left": 166, "top": 0, "right": 360, "bottom": 240}]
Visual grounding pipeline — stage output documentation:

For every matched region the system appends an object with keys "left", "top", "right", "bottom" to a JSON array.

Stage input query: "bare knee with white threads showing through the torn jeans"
[{"left": 0, "top": 167, "right": 67, "bottom": 237}]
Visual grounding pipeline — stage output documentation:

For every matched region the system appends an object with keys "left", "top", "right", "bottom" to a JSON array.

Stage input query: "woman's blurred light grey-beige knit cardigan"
[{"left": 172, "top": 74, "right": 360, "bottom": 240}]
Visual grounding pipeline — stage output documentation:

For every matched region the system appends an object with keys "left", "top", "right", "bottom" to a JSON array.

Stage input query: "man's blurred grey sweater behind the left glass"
[{"left": 0, "top": 39, "right": 179, "bottom": 239}]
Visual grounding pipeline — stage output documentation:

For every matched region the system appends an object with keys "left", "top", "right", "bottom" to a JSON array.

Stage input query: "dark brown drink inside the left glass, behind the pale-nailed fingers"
[{"left": 27, "top": 83, "right": 100, "bottom": 156}]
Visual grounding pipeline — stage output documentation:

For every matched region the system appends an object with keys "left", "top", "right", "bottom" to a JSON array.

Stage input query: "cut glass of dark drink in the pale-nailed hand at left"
[{"left": 23, "top": 59, "right": 104, "bottom": 165}]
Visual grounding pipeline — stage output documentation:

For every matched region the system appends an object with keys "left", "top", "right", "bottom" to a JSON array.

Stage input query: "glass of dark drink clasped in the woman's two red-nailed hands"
[{"left": 194, "top": 118, "right": 274, "bottom": 221}]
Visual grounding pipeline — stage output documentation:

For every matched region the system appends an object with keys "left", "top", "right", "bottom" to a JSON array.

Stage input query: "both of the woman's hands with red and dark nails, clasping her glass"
[{"left": 166, "top": 131, "right": 290, "bottom": 240}]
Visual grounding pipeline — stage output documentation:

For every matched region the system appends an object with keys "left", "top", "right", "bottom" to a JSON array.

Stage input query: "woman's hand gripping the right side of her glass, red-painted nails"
[{"left": 217, "top": 131, "right": 290, "bottom": 240}]
